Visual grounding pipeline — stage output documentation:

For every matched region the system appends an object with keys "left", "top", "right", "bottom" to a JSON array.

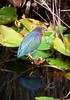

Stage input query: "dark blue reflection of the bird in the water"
[{"left": 19, "top": 76, "right": 44, "bottom": 92}]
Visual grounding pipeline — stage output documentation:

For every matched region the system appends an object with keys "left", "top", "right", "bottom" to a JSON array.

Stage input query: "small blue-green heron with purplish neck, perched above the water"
[{"left": 17, "top": 26, "right": 43, "bottom": 58}]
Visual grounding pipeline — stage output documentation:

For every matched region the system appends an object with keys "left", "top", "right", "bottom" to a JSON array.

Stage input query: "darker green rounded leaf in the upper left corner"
[{"left": 0, "top": 7, "right": 17, "bottom": 24}]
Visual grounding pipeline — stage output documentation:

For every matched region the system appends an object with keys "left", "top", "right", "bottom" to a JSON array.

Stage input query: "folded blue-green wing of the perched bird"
[{"left": 17, "top": 32, "right": 40, "bottom": 57}]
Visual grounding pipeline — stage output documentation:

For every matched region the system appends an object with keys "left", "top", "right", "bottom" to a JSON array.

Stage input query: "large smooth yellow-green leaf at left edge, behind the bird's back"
[{"left": 0, "top": 25, "right": 23, "bottom": 47}]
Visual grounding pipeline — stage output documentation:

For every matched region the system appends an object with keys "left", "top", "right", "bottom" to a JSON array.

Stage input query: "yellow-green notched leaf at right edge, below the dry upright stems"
[{"left": 53, "top": 35, "right": 70, "bottom": 56}]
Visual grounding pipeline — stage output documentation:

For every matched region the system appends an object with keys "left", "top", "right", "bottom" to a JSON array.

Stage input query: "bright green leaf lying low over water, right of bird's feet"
[{"left": 46, "top": 58, "right": 70, "bottom": 69}]
